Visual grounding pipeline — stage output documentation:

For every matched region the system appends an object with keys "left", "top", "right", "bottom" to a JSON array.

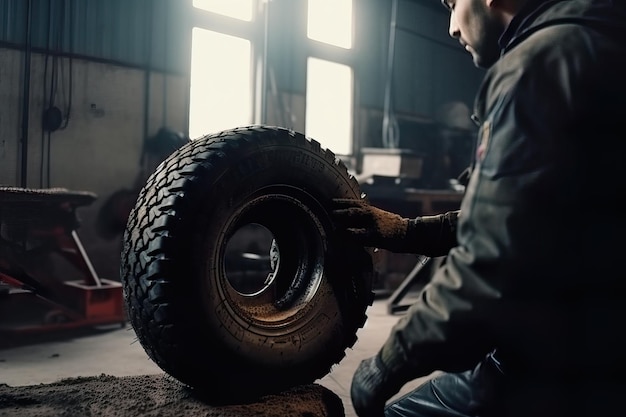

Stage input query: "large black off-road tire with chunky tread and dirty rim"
[{"left": 121, "top": 126, "right": 373, "bottom": 400}]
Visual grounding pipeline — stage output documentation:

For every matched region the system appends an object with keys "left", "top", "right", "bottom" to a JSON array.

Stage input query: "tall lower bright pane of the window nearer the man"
[{"left": 305, "top": 58, "right": 352, "bottom": 155}]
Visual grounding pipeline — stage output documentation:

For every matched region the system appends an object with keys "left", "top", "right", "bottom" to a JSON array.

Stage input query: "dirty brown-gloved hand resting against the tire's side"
[{"left": 332, "top": 198, "right": 409, "bottom": 249}]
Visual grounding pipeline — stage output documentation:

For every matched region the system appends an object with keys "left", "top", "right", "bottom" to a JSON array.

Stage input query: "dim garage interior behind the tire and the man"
[{"left": 0, "top": 0, "right": 483, "bottom": 416}]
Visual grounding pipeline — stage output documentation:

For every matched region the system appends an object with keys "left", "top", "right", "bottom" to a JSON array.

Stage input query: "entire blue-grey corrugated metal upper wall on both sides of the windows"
[{"left": 0, "top": 0, "right": 482, "bottom": 115}]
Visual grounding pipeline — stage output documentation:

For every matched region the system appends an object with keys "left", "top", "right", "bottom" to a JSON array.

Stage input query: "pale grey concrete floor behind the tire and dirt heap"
[{"left": 0, "top": 290, "right": 428, "bottom": 417}]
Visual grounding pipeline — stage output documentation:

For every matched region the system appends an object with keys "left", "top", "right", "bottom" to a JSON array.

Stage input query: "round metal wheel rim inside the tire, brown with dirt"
[{"left": 212, "top": 185, "right": 330, "bottom": 333}]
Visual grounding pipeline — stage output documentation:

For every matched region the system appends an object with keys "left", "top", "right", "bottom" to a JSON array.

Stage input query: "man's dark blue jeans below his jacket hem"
[{"left": 385, "top": 354, "right": 626, "bottom": 417}]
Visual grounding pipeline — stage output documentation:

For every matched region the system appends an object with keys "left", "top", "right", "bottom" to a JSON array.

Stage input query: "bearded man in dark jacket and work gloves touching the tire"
[{"left": 334, "top": 0, "right": 626, "bottom": 417}]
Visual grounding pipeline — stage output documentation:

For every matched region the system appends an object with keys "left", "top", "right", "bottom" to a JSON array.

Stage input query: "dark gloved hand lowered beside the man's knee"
[{"left": 350, "top": 355, "right": 402, "bottom": 417}]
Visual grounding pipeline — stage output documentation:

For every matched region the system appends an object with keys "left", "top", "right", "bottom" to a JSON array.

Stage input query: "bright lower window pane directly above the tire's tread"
[{"left": 189, "top": 28, "right": 252, "bottom": 139}]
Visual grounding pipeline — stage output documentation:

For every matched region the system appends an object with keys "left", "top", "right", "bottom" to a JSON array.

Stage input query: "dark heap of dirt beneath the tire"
[{"left": 0, "top": 374, "right": 345, "bottom": 417}]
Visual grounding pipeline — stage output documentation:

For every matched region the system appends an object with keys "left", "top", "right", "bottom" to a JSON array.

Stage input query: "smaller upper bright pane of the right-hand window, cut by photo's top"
[{"left": 307, "top": 0, "right": 352, "bottom": 49}]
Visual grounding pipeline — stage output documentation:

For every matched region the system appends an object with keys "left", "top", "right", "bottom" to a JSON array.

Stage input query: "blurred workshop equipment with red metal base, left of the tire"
[{"left": 0, "top": 187, "right": 126, "bottom": 332}]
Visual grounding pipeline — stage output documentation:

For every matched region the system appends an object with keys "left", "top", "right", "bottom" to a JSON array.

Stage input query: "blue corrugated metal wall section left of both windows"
[{"left": 0, "top": 0, "right": 190, "bottom": 73}]
